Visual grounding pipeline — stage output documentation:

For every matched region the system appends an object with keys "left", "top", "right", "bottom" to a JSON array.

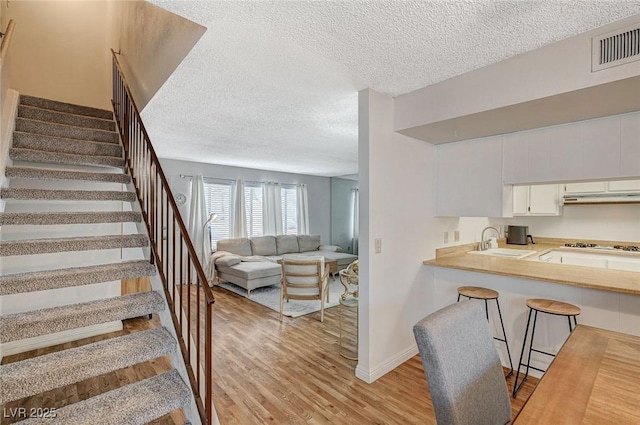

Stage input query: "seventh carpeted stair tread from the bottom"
[{"left": 0, "top": 187, "right": 136, "bottom": 202}]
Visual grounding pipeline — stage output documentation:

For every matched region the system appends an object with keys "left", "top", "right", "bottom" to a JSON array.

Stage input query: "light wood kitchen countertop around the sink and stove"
[{"left": 423, "top": 238, "right": 640, "bottom": 295}]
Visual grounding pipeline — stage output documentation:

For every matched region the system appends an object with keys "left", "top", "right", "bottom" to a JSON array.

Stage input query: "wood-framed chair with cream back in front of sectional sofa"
[{"left": 280, "top": 256, "right": 329, "bottom": 322}]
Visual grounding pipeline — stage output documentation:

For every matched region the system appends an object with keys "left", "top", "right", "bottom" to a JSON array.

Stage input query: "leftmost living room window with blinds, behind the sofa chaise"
[{"left": 204, "top": 179, "right": 233, "bottom": 250}]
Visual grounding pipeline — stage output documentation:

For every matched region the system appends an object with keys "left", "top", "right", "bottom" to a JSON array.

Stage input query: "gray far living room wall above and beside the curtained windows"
[{"left": 160, "top": 158, "right": 331, "bottom": 243}]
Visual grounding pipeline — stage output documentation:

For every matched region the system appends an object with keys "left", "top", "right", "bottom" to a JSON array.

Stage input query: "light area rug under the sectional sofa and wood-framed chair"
[{"left": 217, "top": 279, "right": 344, "bottom": 317}]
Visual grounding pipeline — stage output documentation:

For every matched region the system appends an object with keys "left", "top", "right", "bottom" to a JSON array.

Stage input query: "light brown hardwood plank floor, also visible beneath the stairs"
[{"left": 1, "top": 287, "right": 537, "bottom": 425}]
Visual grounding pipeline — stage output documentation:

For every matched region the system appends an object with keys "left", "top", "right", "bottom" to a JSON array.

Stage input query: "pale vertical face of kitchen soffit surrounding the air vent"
[{"left": 395, "top": 15, "right": 640, "bottom": 129}]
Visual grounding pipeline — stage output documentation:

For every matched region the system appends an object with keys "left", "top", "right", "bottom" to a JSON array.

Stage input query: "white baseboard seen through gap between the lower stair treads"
[{"left": 0, "top": 320, "right": 122, "bottom": 360}]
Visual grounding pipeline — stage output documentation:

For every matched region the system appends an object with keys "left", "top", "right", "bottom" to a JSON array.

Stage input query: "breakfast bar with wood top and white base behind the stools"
[{"left": 423, "top": 238, "right": 640, "bottom": 376}]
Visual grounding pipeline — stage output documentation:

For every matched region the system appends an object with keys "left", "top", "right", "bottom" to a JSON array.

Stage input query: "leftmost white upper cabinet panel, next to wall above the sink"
[{"left": 437, "top": 136, "right": 503, "bottom": 217}]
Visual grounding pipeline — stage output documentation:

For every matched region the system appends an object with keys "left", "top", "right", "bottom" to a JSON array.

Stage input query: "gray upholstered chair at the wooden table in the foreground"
[{"left": 413, "top": 301, "right": 511, "bottom": 425}]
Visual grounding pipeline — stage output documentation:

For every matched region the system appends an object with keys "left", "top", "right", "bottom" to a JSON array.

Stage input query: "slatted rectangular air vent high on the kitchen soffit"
[{"left": 591, "top": 24, "right": 640, "bottom": 72}]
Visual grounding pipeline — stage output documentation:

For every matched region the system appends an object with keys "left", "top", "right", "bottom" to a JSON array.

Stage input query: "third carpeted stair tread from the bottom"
[{"left": 0, "top": 291, "right": 165, "bottom": 343}]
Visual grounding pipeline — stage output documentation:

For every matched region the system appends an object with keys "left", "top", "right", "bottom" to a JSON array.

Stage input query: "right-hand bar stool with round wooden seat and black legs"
[{"left": 513, "top": 298, "right": 581, "bottom": 398}]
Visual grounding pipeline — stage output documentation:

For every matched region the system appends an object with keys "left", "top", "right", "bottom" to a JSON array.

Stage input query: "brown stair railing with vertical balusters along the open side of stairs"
[{"left": 111, "top": 49, "right": 215, "bottom": 424}]
